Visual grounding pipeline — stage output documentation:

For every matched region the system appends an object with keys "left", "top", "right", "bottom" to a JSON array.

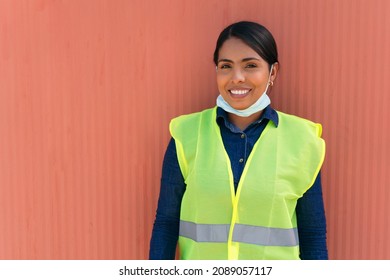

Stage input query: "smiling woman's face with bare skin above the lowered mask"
[{"left": 217, "top": 37, "right": 277, "bottom": 110}]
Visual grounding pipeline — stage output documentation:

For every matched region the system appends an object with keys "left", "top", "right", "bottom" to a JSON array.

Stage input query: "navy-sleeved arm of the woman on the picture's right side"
[{"left": 296, "top": 173, "right": 328, "bottom": 260}]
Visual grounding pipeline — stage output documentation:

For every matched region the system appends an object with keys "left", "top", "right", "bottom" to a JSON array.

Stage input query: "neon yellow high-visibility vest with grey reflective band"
[{"left": 170, "top": 107, "right": 325, "bottom": 260}]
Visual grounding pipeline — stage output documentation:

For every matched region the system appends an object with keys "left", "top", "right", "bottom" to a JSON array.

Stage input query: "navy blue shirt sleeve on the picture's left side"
[{"left": 149, "top": 138, "right": 186, "bottom": 260}]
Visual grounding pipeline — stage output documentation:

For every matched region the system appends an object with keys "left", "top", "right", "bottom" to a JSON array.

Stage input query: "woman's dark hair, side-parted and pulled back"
[{"left": 214, "top": 21, "right": 278, "bottom": 67}]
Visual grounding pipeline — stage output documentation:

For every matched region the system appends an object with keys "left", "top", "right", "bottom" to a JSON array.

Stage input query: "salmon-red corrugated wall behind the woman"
[{"left": 0, "top": 0, "right": 390, "bottom": 259}]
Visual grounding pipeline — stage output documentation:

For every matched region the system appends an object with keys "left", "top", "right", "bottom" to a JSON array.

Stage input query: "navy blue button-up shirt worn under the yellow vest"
[{"left": 149, "top": 106, "right": 328, "bottom": 260}]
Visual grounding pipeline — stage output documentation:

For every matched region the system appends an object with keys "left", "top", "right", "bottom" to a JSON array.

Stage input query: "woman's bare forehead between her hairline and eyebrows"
[{"left": 218, "top": 37, "right": 263, "bottom": 60}]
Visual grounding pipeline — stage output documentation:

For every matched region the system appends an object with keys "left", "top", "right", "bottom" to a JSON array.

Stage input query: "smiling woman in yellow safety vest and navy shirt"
[{"left": 149, "top": 22, "right": 328, "bottom": 259}]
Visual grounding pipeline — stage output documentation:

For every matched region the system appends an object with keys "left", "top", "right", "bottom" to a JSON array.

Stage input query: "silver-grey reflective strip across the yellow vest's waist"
[{"left": 179, "top": 221, "right": 299, "bottom": 246}]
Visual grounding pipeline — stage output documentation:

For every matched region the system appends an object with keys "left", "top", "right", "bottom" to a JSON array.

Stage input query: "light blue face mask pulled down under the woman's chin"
[{"left": 217, "top": 65, "right": 274, "bottom": 117}]
